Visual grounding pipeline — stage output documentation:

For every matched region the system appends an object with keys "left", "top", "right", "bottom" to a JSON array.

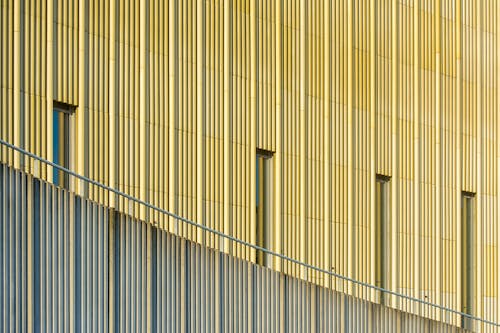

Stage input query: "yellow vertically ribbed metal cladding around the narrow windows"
[{"left": 0, "top": 0, "right": 500, "bottom": 324}]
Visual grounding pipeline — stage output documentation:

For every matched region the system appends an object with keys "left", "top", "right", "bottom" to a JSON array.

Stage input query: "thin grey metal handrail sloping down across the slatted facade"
[{"left": 0, "top": 139, "right": 500, "bottom": 327}]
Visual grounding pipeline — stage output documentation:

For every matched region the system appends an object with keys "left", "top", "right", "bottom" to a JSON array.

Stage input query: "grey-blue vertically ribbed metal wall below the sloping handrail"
[{"left": 0, "top": 164, "right": 476, "bottom": 332}]
